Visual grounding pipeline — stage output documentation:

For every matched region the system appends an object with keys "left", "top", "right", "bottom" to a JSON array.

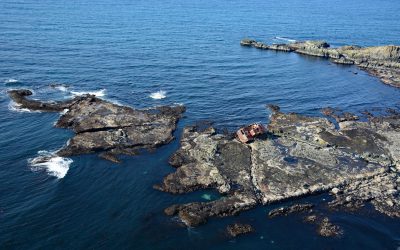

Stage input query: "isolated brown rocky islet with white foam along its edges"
[{"left": 8, "top": 90, "right": 185, "bottom": 162}]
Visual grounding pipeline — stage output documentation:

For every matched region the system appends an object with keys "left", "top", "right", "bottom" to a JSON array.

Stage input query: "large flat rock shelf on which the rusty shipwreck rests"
[{"left": 155, "top": 106, "right": 400, "bottom": 229}]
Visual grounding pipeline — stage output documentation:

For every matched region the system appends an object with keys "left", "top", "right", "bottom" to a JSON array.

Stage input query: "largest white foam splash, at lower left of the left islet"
[{"left": 28, "top": 150, "right": 73, "bottom": 179}]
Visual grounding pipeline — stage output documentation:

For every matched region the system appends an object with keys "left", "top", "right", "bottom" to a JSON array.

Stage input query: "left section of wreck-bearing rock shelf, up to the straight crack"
[{"left": 154, "top": 127, "right": 257, "bottom": 226}]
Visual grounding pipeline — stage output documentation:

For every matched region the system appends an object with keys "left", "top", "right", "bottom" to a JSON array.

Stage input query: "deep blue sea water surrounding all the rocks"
[{"left": 0, "top": 0, "right": 400, "bottom": 249}]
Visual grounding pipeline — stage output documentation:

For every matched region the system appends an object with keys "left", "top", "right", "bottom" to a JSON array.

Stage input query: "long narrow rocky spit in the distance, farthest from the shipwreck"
[{"left": 240, "top": 39, "right": 400, "bottom": 87}]
